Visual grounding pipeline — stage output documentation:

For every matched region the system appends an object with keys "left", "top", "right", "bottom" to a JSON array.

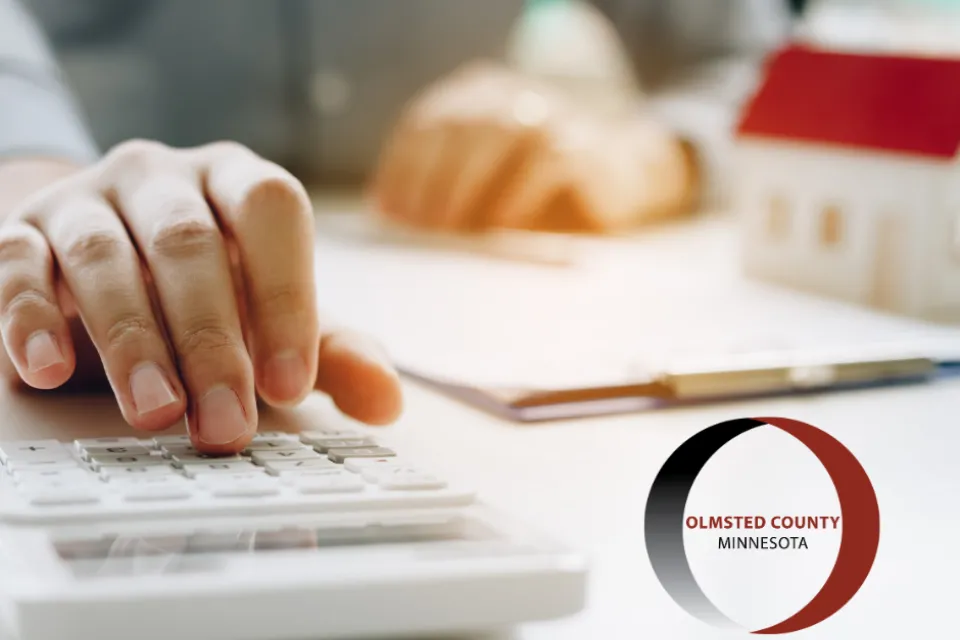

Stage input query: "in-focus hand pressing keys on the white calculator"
[{"left": 0, "top": 141, "right": 400, "bottom": 453}]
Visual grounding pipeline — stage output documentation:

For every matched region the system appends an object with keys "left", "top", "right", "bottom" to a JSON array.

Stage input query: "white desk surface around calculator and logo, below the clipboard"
[{"left": 0, "top": 201, "right": 960, "bottom": 640}]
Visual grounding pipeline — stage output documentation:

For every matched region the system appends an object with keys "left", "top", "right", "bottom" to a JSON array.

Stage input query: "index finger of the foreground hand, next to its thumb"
[{"left": 199, "top": 144, "right": 320, "bottom": 405}]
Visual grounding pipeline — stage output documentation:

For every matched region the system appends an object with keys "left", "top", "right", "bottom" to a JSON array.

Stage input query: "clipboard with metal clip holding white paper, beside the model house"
[{"left": 318, "top": 219, "right": 960, "bottom": 420}]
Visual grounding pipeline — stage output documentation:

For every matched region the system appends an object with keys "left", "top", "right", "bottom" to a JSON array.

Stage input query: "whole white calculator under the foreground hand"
[{"left": 0, "top": 429, "right": 586, "bottom": 640}]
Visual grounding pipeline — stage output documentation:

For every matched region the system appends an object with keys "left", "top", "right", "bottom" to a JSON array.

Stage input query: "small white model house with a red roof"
[{"left": 736, "top": 45, "right": 960, "bottom": 321}]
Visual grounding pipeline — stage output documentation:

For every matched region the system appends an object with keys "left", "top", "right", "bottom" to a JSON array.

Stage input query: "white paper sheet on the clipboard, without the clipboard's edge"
[{"left": 318, "top": 214, "right": 960, "bottom": 396}]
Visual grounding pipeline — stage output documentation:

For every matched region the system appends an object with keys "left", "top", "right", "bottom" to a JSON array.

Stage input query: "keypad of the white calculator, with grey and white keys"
[{"left": 0, "top": 429, "right": 472, "bottom": 520}]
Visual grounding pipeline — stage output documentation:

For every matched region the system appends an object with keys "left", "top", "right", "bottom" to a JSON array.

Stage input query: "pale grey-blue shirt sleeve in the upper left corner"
[{"left": 0, "top": 0, "right": 99, "bottom": 163}]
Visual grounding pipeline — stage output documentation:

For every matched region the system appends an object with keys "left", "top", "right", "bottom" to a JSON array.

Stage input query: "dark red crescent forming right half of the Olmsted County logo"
[{"left": 752, "top": 418, "right": 880, "bottom": 634}]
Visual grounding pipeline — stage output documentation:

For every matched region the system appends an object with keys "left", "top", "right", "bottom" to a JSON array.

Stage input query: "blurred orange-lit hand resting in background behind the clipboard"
[{"left": 373, "top": 66, "right": 696, "bottom": 231}]
